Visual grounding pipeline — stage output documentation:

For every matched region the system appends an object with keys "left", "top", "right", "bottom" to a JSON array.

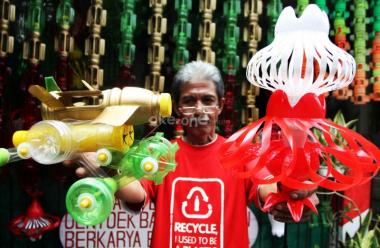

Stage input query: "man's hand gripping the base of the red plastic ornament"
[{"left": 259, "top": 184, "right": 319, "bottom": 223}]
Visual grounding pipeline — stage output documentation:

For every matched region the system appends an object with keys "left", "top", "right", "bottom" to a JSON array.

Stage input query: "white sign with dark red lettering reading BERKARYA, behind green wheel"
[{"left": 59, "top": 200, "right": 154, "bottom": 248}]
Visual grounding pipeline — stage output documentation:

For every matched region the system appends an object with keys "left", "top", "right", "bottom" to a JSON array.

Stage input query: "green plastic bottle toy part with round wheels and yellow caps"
[{"left": 66, "top": 133, "right": 178, "bottom": 225}]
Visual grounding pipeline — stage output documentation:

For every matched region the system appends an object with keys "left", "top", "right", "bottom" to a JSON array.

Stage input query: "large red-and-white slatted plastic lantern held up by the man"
[{"left": 220, "top": 5, "right": 380, "bottom": 221}]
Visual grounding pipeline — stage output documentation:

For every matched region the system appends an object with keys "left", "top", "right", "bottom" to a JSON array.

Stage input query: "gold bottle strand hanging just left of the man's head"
[{"left": 145, "top": 0, "right": 167, "bottom": 92}]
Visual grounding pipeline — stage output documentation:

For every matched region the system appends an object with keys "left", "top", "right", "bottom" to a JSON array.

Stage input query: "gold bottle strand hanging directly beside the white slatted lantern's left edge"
[{"left": 241, "top": 0, "right": 263, "bottom": 124}]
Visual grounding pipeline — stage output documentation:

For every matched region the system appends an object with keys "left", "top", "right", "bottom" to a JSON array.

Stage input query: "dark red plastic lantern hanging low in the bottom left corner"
[{"left": 9, "top": 196, "right": 60, "bottom": 242}]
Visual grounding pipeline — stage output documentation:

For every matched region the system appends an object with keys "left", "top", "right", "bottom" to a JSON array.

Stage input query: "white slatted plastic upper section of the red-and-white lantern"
[{"left": 247, "top": 4, "right": 356, "bottom": 106}]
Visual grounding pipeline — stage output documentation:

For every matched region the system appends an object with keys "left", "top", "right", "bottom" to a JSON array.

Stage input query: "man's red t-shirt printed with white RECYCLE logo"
[{"left": 142, "top": 136, "right": 257, "bottom": 248}]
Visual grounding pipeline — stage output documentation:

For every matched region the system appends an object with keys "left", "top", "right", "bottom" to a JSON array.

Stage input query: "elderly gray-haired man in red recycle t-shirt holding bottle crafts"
[{"left": 75, "top": 61, "right": 313, "bottom": 247}]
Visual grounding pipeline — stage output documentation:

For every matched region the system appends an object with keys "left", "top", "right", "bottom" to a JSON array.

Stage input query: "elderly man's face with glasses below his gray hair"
[{"left": 176, "top": 80, "right": 223, "bottom": 138}]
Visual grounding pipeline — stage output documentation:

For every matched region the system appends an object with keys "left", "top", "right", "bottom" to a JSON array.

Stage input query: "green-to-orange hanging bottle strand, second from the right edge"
[{"left": 351, "top": 0, "right": 370, "bottom": 104}]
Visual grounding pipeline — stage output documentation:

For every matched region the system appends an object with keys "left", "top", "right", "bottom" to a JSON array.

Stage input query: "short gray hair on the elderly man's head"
[{"left": 172, "top": 60, "right": 224, "bottom": 103}]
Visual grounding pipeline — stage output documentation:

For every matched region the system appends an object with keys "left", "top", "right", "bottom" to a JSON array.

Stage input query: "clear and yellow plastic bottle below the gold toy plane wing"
[{"left": 13, "top": 120, "right": 134, "bottom": 164}]
